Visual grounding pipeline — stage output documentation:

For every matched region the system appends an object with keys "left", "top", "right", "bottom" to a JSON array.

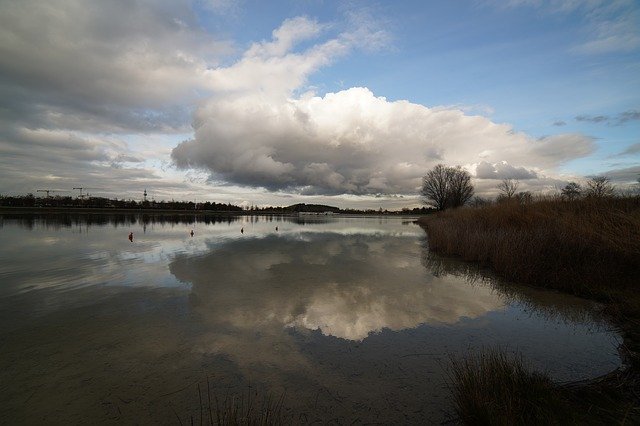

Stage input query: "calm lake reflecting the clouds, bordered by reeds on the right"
[{"left": 0, "top": 214, "right": 622, "bottom": 424}]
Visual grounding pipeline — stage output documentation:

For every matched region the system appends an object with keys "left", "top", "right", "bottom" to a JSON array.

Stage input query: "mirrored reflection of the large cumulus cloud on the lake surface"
[{"left": 170, "top": 233, "right": 504, "bottom": 340}]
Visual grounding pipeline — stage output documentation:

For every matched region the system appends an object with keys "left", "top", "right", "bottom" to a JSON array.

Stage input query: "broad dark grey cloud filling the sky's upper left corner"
[{"left": 0, "top": 0, "right": 228, "bottom": 131}]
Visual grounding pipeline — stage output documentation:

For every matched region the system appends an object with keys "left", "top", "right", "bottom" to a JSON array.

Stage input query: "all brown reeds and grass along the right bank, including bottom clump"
[{"left": 420, "top": 197, "right": 640, "bottom": 424}]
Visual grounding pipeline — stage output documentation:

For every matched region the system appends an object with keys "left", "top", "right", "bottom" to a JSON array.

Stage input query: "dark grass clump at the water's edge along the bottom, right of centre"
[{"left": 451, "top": 350, "right": 574, "bottom": 425}]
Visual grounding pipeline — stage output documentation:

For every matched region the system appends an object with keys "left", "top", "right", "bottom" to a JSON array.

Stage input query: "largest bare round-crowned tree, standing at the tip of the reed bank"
[{"left": 422, "top": 164, "right": 473, "bottom": 210}]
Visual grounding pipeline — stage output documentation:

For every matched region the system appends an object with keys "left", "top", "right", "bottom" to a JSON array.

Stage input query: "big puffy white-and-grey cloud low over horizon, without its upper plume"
[{"left": 172, "top": 88, "right": 594, "bottom": 195}]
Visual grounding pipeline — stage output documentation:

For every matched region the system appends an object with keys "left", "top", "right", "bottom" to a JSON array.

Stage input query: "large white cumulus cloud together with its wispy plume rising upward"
[{"left": 172, "top": 18, "right": 594, "bottom": 195}]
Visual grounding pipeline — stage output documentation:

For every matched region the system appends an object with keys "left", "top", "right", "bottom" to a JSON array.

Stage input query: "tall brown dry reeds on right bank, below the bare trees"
[{"left": 420, "top": 197, "right": 640, "bottom": 300}]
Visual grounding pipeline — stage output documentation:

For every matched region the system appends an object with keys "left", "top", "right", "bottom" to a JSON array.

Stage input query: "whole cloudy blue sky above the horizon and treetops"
[{"left": 0, "top": 0, "right": 640, "bottom": 209}]
